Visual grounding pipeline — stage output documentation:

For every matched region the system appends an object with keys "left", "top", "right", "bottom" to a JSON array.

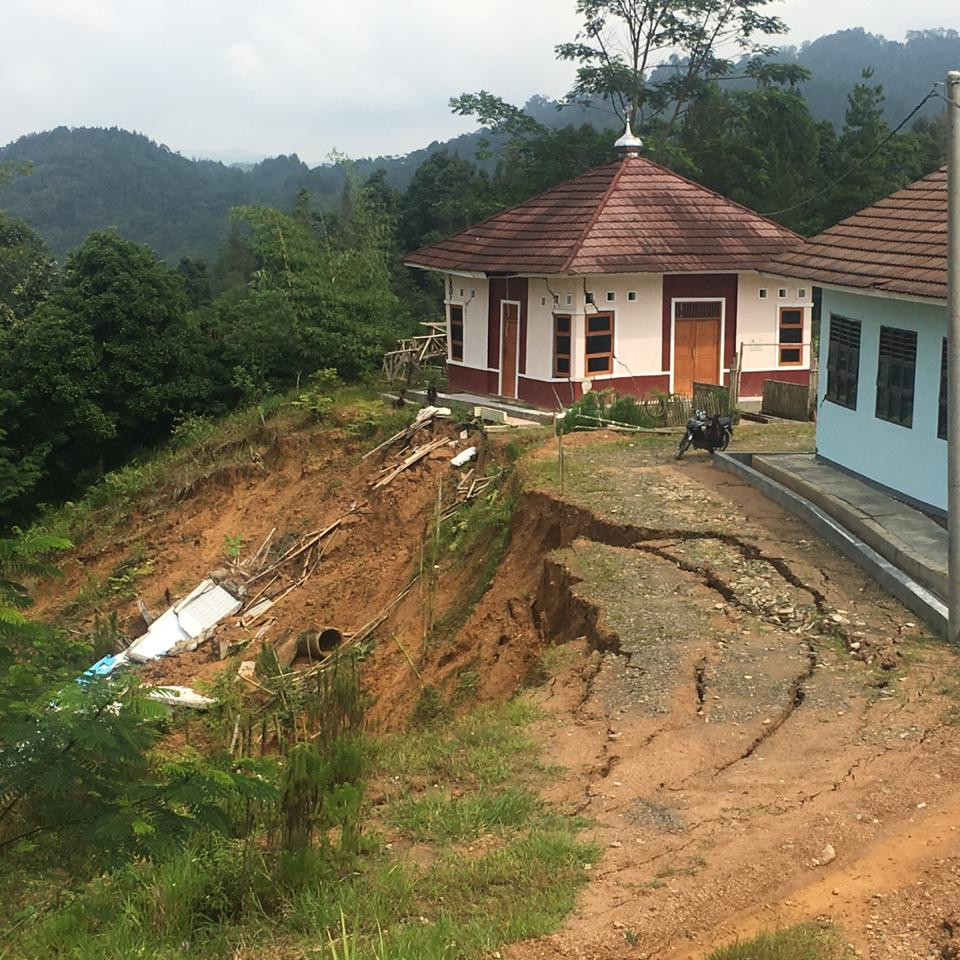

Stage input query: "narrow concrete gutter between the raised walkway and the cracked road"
[{"left": 713, "top": 452, "right": 947, "bottom": 633}]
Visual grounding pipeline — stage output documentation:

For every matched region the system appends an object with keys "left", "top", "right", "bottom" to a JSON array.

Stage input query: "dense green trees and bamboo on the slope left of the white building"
[{"left": 0, "top": 168, "right": 404, "bottom": 528}]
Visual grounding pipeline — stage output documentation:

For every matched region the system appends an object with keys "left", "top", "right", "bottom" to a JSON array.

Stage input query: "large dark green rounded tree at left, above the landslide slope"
[{"left": 0, "top": 232, "right": 211, "bottom": 510}]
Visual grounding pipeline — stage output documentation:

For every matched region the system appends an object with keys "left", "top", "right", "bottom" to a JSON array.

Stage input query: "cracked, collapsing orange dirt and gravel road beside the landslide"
[{"left": 506, "top": 430, "right": 960, "bottom": 960}]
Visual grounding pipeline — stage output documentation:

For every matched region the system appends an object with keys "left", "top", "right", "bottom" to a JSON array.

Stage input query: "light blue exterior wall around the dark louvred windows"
[{"left": 817, "top": 289, "right": 947, "bottom": 511}]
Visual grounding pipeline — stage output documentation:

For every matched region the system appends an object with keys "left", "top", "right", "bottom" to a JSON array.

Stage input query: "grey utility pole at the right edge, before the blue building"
[{"left": 947, "top": 70, "right": 960, "bottom": 644}]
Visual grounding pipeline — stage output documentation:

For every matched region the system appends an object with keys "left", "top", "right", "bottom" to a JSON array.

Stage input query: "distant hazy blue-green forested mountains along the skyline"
[{"left": 0, "top": 29, "right": 960, "bottom": 263}]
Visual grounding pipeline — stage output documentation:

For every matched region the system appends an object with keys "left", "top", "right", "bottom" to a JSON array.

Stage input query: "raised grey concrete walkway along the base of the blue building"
[{"left": 753, "top": 453, "right": 947, "bottom": 599}]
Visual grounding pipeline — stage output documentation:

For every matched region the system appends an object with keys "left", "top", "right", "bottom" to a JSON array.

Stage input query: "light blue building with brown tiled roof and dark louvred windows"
[{"left": 770, "top": 168, "right": 947, "bottom": 516}]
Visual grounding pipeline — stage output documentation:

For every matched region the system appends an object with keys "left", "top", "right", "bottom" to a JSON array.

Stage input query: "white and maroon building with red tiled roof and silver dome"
[{"left": 405, "top": 130, "right": 813, "bottom": 409}]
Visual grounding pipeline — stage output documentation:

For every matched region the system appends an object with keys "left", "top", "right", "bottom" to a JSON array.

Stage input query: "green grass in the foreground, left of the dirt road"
[{"left": 13, "top": 702, "right": 600, "bottom": 960}]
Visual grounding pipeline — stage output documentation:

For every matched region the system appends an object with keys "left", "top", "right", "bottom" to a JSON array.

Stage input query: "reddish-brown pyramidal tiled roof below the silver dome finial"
[{"left": 405, "top": 156, "right": 802, "bottom": 275}]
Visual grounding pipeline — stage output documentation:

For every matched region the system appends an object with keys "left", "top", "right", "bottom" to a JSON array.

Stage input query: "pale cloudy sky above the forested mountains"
[{"left": 0, "top": 0, "right": 954, "bottom": 163}]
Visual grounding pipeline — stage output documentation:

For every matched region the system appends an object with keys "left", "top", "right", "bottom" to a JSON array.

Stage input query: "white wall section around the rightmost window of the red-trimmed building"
[{"left": 737, "top": 272, "right": 813, "bottom": 372}]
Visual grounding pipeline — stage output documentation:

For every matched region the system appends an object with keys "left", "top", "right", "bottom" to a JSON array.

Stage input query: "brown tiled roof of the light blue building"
[{"left": 768, "top": 167, "right": 947, "bottom": 300}]
